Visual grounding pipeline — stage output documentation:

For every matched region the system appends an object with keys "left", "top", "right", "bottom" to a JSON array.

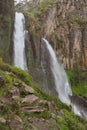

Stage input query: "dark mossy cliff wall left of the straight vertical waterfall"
[{"left": 0, "top": 0, "right": 14, "bottom": 62}]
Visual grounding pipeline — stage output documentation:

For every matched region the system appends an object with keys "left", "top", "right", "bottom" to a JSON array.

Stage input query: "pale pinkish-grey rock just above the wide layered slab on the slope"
[{"left": 22, "top": 95, "right": 39, "bottom": 103}]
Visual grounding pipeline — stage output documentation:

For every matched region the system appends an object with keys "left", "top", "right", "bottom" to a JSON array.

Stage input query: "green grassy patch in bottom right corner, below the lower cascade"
[{"left": 56, "top": 109, "right": 87, "bottom": 130}]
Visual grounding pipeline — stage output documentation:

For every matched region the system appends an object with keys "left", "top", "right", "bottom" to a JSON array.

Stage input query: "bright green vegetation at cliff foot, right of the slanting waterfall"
[{"left": 67, "top": 68, "right": 87, "bottom": 97}]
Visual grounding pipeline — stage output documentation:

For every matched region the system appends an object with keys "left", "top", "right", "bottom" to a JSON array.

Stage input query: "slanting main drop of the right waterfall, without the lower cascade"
[{"left": 42, "top": 38, "right": 72, "bottom": 105}]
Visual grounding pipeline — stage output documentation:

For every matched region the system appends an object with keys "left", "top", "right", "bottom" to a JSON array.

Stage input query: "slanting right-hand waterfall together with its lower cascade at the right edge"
[{"left": 42, "top": 38, "right": 87, "bottom": 119}]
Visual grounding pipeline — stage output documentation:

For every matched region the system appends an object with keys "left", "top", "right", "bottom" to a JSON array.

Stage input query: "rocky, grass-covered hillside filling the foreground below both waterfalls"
[{"left": 0, "top": 63, "right": 87, "bottom": 130}]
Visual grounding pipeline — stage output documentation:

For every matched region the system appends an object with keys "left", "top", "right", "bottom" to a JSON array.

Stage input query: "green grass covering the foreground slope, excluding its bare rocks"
[{"left": 0, "top": 63, "right": 87, "bottom": 130}]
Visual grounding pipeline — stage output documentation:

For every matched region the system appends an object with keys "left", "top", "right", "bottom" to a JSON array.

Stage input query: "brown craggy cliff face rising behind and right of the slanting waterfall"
[{"left": 24, "top": 0, "right": 87, "bottom": 69}]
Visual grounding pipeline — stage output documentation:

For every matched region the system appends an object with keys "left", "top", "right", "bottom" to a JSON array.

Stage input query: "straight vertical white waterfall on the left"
[{"left": 14, "top": 12, "right": 27, "bottom": 70}]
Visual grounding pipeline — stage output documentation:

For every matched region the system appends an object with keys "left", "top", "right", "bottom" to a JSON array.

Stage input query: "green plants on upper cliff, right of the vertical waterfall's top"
[{"left": 24, "top": 0, "right": 55, "bottom": 37}]
